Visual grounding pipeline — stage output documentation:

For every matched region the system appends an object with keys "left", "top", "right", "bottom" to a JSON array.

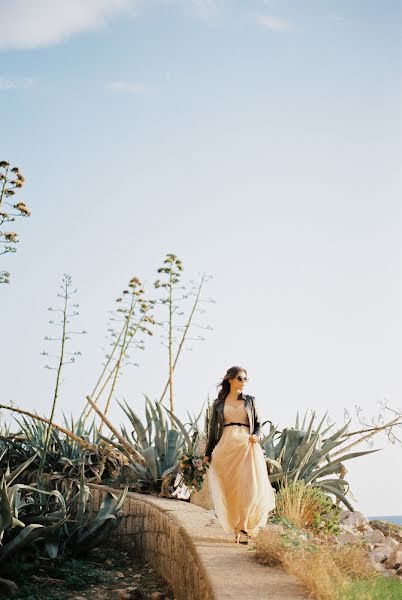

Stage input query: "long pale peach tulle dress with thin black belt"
[{"left": 208, "top": 402, "right": 275, "bottom": 535}]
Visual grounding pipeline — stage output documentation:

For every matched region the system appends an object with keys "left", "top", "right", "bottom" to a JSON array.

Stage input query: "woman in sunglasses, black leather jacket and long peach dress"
[{"left": 204, "top": 366, "right": 275, "bottom": 544}]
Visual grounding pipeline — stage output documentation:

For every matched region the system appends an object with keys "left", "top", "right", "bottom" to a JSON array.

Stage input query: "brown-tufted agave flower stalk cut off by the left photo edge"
[{"left": 0, "top": 160, "right": 31, "bottom": 283}]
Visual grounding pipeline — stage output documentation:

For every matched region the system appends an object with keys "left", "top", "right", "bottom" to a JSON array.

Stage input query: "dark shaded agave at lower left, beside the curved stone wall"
[{"left": 0, "top": 454, "right": 128, "bottom": 565}]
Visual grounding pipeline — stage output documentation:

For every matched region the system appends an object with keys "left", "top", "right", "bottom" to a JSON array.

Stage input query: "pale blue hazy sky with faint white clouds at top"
[{"left": 0, "top": 0, "right": 402, "bottom": 514}]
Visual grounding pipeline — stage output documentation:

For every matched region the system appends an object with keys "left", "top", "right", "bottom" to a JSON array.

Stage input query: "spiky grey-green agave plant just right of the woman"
[{"left": 261, "top": 413, "right": 377, "bottom": 510}]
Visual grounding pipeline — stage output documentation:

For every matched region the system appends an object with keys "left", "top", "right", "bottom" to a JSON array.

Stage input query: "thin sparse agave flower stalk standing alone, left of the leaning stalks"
[{"left": 38, "top": 273, "right": 87, "bottom": 481}]
